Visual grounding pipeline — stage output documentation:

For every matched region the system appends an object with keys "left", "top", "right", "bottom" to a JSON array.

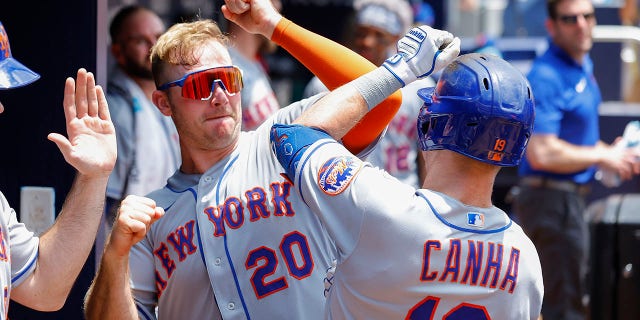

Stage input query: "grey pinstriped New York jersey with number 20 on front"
[{"left": 130, "top": 94, "right": 380, "bottom": 319}]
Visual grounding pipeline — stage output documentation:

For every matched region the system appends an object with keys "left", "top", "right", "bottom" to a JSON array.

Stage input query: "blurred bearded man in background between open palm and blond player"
[{"left": 106, "top": 5, "right": 180, "bottom": 227}]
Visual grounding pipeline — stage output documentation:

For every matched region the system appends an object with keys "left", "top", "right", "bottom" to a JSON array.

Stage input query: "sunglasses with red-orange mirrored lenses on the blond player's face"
[{"left": 158, "top": 66, "right": 243, "bottom": 100}]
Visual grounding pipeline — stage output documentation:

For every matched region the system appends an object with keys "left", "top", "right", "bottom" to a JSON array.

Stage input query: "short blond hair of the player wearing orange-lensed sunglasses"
[{"left": 151, "top": 19, "right": 230, "bottom": 86}]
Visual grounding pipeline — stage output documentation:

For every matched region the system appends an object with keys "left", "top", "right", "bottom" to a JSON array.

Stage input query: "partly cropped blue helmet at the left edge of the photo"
[{"left": 0, "top": 22, "right": 40, "bottom": 90}]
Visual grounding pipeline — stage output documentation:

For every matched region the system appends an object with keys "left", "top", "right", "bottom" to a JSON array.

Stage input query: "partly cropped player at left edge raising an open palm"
[{"left": 0, "top": 23, "right": 116, "bottom": 319}]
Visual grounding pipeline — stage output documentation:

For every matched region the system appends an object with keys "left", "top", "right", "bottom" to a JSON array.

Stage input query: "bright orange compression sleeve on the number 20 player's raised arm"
[{"left": 271, "top": 18, "right": 402, "bottom": 154}]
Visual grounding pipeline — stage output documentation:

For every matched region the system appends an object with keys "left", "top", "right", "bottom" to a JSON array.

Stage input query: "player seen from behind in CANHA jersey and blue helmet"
[{"left": 271, "top": 54, "right": 543, "bottom": 320}]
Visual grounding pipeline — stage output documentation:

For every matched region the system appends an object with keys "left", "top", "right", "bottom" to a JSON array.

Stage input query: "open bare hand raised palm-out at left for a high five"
[{"left": 47, "top": 69, "right": 116, "bottom": 177}]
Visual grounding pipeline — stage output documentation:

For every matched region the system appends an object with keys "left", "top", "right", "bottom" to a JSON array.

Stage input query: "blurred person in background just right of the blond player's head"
[{"left": 227, "top": 0, "right": 282, "bottom": 131}]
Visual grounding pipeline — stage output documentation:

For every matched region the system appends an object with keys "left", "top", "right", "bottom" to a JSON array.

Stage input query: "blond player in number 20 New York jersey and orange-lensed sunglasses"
[{"left": 86, "top": 0, "right": 459, "bottom": 319}]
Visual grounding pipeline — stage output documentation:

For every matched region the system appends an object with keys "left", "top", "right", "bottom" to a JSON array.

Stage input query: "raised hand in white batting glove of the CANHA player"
[{"left": 383, "top": 25, "right": 460, "bottom": 86}]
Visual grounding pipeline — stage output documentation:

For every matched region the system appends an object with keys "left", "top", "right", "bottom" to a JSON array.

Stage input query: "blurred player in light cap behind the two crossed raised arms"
[{"left": 304, "top": 0, "right": 435, "bottom": 188}]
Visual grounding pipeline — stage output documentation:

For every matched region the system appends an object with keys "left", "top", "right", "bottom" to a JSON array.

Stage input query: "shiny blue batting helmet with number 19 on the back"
[{"left": 418, "top": 53, "right": 534, "bottom": 166}]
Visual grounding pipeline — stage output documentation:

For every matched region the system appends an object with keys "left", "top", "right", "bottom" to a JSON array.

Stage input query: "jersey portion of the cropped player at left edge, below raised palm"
[{"left": 0, "top": 193, "right": 39, "bottom": 319}]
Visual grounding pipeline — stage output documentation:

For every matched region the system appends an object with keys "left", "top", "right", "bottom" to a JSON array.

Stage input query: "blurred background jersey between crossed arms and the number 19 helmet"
[{"left": 304, "top": 77, "right": 435, "bottom": 188}]
